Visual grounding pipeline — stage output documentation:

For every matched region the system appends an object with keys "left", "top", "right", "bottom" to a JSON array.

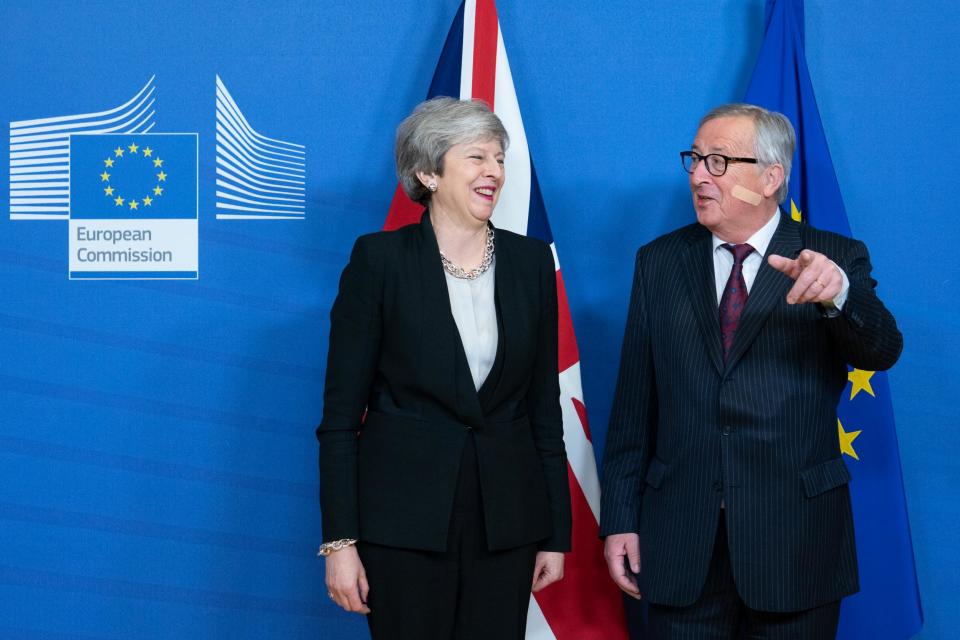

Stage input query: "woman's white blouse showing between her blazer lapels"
[{"left": 443, "top": 258, "right": 498, "bottom": 389}]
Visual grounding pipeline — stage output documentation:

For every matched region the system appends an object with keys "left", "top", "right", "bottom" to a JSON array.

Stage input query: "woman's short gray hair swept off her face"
[{"left": 394, "top": 97, "right": 510, "bottom": 205}]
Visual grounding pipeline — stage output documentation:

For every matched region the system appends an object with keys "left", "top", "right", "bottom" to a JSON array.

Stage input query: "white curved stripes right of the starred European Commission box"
[{"left": 217, "top": 75, "right": 307, "bottom": 220}]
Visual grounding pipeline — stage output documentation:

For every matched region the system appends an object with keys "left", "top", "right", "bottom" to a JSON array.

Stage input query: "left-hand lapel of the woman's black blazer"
[{"left": 419, "top": 210, "right": 484, "bottom": 428}]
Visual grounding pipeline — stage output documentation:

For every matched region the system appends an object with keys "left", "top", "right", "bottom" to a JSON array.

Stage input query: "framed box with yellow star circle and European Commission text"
[{"left": 69, "top": 133, "right": 198, "bottom": 280}]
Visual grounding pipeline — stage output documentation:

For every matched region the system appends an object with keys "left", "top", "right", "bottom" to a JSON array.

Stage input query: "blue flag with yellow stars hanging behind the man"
[{"left": 746, "top": 0, "right": 923, "bottom": 640}]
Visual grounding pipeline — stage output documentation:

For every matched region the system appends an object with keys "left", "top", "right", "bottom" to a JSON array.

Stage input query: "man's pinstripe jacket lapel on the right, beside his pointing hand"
[{"left": 727, "top": 213, "right": 803, "bottom": 370}]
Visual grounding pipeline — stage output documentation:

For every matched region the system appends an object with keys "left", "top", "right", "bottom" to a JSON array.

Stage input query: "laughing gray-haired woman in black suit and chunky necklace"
[{"left": 317, "top": 98, "right": 570, "bottom": 640}]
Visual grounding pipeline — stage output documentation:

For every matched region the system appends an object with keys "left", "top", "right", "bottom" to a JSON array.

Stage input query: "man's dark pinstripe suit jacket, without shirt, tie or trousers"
[{"left": 600, "top": 216, "right": 902, "bottom": 612}]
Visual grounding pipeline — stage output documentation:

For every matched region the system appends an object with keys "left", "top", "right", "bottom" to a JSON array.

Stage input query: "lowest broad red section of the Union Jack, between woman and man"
[{"left": 534, "top": 465, "right": 627, "bottom": 640}]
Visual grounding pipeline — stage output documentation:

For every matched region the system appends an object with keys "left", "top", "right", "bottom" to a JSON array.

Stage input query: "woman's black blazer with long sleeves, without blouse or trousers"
[{"left": 317, "top": 212, "right": 570, "bottom": 551}]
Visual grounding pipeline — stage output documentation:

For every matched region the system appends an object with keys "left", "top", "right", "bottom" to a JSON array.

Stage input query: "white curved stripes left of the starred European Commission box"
[{"left": 10, "top": 76, "right": 156, "bottom": 220}]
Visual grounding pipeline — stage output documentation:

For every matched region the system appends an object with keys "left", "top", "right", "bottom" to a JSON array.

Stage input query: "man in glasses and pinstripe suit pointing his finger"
[{"left": 600, "top": 104, "right": 903, "bottom": 639}]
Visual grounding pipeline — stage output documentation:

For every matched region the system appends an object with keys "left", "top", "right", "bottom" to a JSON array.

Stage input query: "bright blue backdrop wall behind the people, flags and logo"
[{"left": 0, "top": 0, "right": 960, "bottom": 640}]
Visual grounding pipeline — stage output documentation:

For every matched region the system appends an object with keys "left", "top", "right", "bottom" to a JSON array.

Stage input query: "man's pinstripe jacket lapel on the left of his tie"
[{"left": 681, "top": 225, "right": 724, "bottom": 374}]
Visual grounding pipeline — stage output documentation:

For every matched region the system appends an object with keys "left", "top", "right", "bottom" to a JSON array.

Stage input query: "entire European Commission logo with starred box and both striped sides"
[{"left": 10, "top": 76, "right": 306, "bottom": 280}]
